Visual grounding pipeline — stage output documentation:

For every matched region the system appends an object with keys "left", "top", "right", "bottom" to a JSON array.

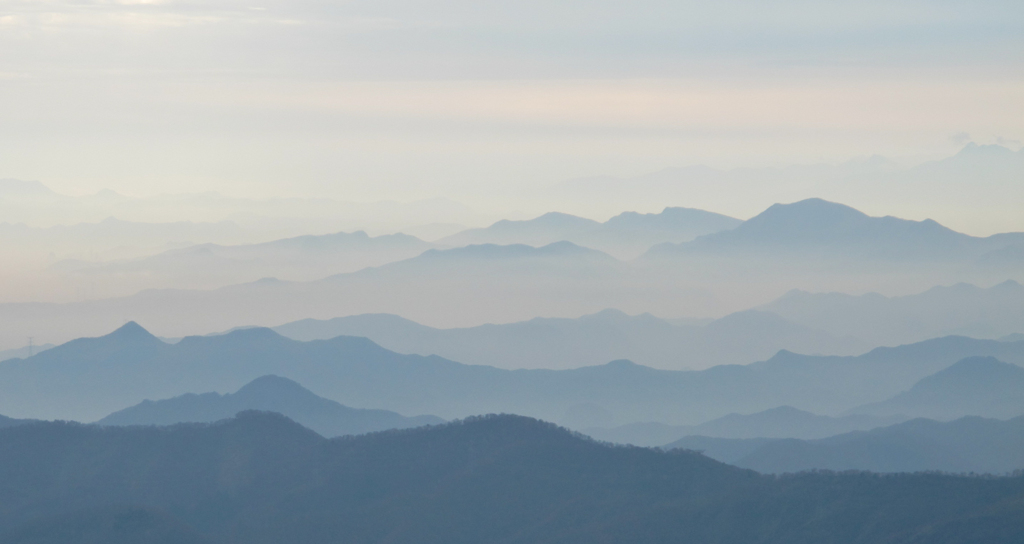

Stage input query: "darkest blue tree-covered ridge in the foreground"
[{"left": 0, "top": 412, "right": 1024, "bottom": 544}]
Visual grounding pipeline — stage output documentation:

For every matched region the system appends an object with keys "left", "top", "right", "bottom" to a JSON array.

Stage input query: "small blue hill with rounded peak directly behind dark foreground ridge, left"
[{"left": 96, "top": 376, "right": 444, "bottom": 437}]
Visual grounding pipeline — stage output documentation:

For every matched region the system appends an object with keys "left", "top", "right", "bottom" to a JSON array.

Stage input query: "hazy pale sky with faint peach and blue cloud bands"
[{"left": 0, "top": 0, "right": 1024, "bottom": 215}]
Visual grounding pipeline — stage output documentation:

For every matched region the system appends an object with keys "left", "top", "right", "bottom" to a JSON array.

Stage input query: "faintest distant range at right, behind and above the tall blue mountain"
[{"left": 550, "top": 142, "right": 1024, "bottom": 236}]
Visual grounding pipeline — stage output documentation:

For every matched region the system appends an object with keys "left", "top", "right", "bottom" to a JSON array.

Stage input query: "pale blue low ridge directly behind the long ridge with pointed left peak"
[{"left": 273, "top": 309, "right": 868, "bottom": 369}]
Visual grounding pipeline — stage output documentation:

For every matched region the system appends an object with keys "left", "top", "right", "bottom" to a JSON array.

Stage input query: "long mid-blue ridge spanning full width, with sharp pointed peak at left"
[{"left": 8, "top": 323, "right": 1024, "bottom": 428}]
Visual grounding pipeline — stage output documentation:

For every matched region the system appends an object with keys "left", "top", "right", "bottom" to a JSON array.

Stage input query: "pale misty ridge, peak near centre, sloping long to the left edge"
[{"left": 0, "top": 242, "right": 655, "bottom": 346}]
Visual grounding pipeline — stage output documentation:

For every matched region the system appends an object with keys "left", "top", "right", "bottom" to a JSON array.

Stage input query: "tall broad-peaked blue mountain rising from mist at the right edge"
[{"left": 634, "top": 199, "right": 1024, "bottom": 321}]
